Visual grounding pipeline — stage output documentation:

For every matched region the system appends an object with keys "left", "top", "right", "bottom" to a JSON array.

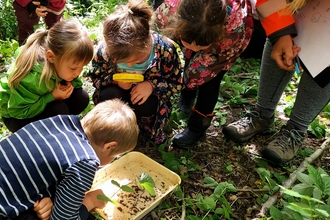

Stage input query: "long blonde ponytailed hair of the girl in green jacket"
[{"left": 8, "top": 19, "right": 94, "bottom": 89}]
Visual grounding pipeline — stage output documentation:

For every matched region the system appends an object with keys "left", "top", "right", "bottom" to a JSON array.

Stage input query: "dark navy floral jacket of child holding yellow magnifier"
[{"left": 88, "top": 32, "right": 183, "bottom": 141}]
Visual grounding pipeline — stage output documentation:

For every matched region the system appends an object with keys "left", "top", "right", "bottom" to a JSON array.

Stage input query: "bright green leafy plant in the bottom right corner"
[{"left": 269, "top": 164, "right": 330, "bottom": 220}]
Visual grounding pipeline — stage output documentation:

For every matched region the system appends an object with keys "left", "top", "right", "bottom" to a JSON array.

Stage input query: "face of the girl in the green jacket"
[{"left": 54, "top": 58, "right": 86, "bottom": 82}]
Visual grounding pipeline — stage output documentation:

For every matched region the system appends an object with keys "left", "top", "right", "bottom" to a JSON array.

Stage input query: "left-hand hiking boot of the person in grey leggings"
[{"left": 222, "top": 108, "right": 274, "bottom": 143}]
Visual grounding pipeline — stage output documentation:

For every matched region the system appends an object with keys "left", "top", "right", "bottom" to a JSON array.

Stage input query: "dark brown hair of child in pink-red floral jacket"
[{"left": 174, "top": 0, "right": 227, "bottom": 46}]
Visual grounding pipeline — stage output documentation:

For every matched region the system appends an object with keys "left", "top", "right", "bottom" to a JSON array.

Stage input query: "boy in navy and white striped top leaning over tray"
[{"left": 0, "top": 100, "right": 139, "bottom": 220}]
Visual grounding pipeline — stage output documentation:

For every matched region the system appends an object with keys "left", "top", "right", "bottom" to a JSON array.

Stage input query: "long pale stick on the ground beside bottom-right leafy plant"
[{"left": 256, "top": 138, "right": 330, "bottom": 218}]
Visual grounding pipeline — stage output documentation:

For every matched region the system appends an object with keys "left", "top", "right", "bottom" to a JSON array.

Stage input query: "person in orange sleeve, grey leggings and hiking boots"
[{"left": 222, "top": 0, "right": 330, "bottom": 166}]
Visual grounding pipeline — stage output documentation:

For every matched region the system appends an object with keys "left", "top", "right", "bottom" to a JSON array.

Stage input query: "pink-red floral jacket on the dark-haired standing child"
[{"left": 154, "top": 0, "right": 253, "bottom": 89}]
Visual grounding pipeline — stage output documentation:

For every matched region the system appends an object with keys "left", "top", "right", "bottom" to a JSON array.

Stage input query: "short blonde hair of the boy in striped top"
[{"left": 82, "top": 99, "right": 139, "bottom": 152}]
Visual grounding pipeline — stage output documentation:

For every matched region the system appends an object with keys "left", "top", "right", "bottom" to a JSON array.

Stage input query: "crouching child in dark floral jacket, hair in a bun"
[{"left": 89, "top": 0, "right": 182, "bottom": 144}]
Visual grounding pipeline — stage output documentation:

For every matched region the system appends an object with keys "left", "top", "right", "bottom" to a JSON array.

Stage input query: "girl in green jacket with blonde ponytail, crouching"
[{"left": 0, "top": 19, "right": 94, "bottom": 132}]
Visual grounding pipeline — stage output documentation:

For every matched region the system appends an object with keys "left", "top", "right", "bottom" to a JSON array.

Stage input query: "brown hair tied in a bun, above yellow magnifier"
[{"left": 103, "top": 0, "right": 152, "bottom": 61}]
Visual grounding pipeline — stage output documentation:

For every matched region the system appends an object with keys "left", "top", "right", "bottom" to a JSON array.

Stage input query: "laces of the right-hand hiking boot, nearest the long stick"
[{"left": 275, "top": 129, "right": 303, "bottom": 153}]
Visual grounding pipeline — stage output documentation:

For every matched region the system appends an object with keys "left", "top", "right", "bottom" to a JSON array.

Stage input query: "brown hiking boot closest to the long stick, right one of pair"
[{"left": 261, "top": 124, "right": 305, "bottom": 166}]
